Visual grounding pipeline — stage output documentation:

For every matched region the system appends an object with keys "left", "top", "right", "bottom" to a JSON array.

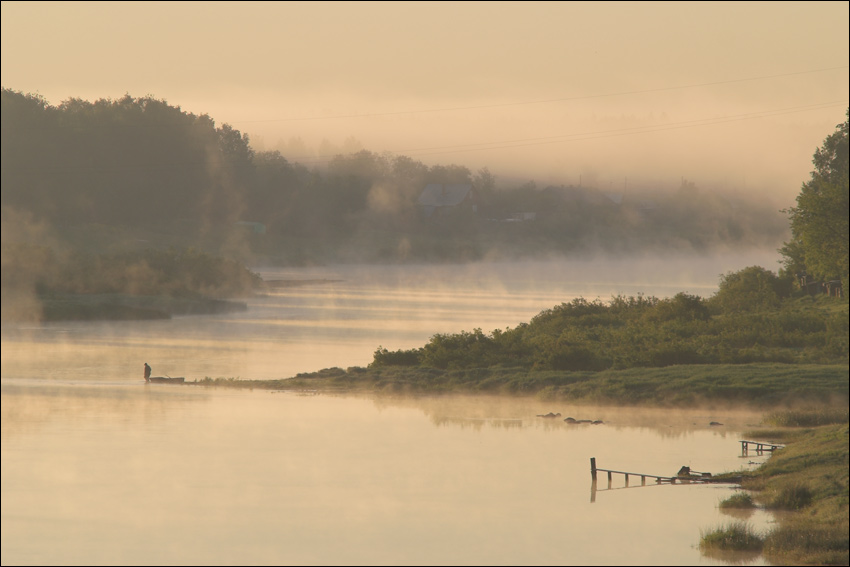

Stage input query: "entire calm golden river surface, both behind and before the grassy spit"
[{"left": 0, "top": 258, "right": 772, "bottom": 565}]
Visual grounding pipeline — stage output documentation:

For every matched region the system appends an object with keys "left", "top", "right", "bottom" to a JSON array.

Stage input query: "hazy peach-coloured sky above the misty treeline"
[{"left": 0, "top": 0, "right": 850, "bottom": 202}]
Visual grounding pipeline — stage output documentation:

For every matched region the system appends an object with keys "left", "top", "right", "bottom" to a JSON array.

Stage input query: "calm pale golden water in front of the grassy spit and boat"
[{"left": 2, "top": 385, "right": 776, "bottom": 565}]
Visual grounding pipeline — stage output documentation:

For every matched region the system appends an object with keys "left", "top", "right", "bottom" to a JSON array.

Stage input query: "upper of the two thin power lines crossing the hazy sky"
[{"left": 229, "top": 65, "right": 848, "bottom": 124}]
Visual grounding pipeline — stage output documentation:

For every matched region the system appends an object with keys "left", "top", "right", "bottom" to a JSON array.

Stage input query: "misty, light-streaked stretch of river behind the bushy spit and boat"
[{"left": 2, "top": 252, "right": 775, "bottom": 382}]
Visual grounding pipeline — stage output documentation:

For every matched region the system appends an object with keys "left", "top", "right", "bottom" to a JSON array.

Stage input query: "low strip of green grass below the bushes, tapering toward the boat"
[{"left": 195, "top": 364, "right": 850, "bottom": 410}]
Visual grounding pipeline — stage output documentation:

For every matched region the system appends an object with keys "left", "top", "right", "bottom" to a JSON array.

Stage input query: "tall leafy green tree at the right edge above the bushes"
[{"left": 780, "top": 108, "right": 850, "bottom": 285}]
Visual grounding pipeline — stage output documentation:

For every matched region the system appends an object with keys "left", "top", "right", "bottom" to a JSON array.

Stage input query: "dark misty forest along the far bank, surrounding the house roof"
[{"left": 2, "top": 89, "right": 788, "bottom": 265}]
